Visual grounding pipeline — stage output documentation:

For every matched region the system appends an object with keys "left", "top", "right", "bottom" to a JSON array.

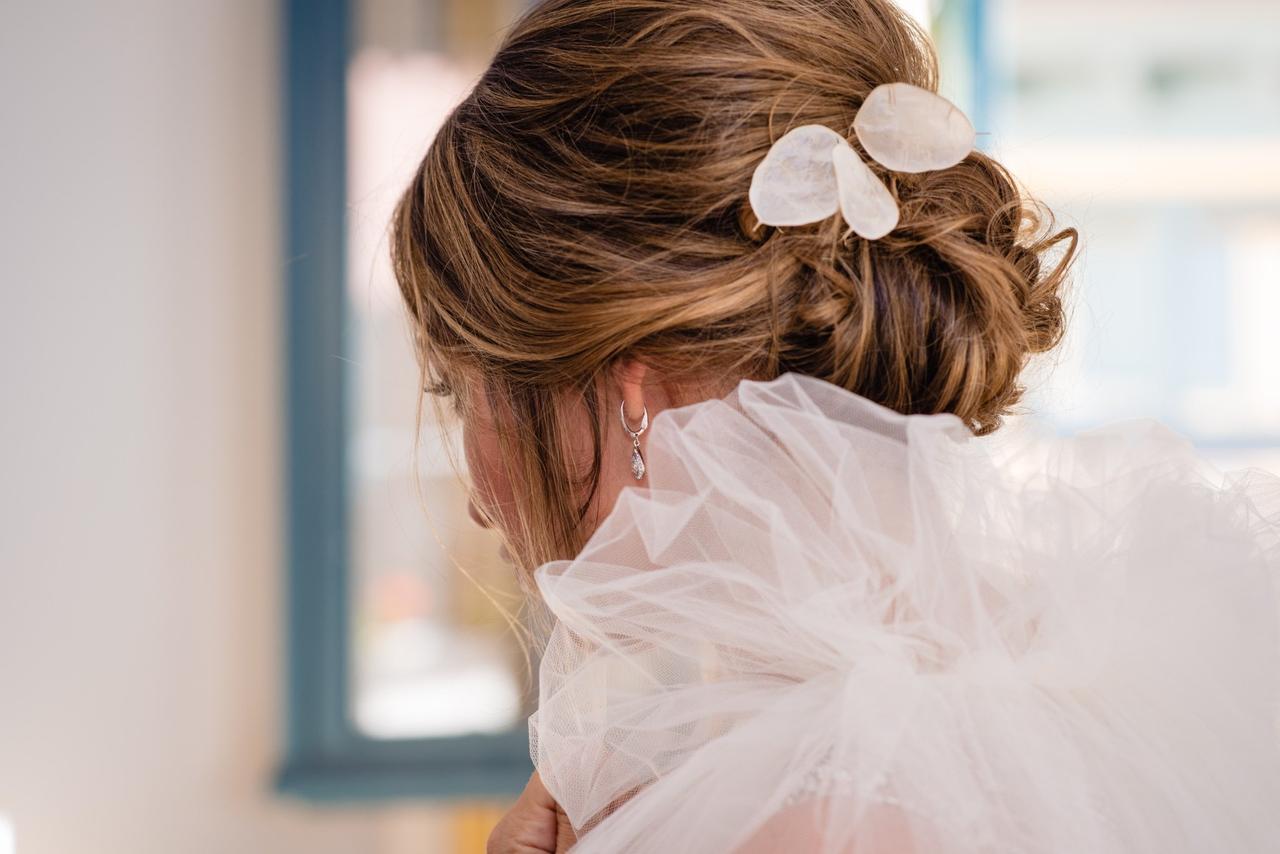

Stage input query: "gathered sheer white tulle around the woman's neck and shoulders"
[{"left": 529, "top": 374, "right": 1280, "bottom": 854}]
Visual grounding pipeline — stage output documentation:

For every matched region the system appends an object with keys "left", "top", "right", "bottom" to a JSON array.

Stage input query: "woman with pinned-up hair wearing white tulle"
[{"left": 393, "top": 0, "right": 1280, "bottom": 854}]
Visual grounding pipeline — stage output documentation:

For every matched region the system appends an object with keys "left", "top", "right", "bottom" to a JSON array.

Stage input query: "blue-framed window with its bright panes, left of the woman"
[{"left": 279, "top": 0, "right": 532, "bottom": 798}]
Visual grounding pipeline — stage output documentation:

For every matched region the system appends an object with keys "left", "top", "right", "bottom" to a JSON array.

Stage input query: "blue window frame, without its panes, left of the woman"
[{"left": 276, "top": 0, "right": 532, "bottom": 800}]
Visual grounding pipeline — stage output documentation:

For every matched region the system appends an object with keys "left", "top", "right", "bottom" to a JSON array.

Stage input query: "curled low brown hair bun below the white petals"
[{"left": 774, "top": 145, "right": 1076, "bottom": 434}]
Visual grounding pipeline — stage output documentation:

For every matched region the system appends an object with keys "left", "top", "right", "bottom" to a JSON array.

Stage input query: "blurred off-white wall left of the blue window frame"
[{"left": 0, "top": 0, "right": 455, "bottom": 854}]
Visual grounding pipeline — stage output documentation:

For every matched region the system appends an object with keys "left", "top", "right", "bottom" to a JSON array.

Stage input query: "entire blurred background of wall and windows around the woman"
[{"left": 0, "top": 0, "right": 1280, "bottom": 854}]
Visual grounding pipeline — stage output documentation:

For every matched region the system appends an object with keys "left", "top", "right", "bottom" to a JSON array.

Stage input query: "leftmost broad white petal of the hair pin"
[{"left": 748, "top": 124, "right": 844, "bottom": 225}]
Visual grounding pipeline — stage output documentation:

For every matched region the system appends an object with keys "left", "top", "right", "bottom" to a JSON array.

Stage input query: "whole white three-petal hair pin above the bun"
[{"left": 748, "top": 83, "right": 977, "bottom": 241}]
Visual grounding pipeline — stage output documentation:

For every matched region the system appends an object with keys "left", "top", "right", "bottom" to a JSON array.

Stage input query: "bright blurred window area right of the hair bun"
[{"left": 988, "top": 0, "right": 1280, "bottom": 470}]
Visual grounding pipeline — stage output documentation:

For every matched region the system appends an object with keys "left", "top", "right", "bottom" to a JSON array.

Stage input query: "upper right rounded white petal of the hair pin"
[{"left": 854, "top": 83, "right": 977, "bottom": 172}]
